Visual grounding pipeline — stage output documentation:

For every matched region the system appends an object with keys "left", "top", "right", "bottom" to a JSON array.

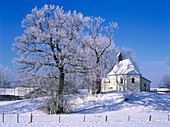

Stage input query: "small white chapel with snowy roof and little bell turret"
[{"left": 101, "top": 53, "right": 151, "bottom": 92}]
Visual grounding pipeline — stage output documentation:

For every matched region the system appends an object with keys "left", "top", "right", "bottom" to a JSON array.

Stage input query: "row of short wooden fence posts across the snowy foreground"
[{"left": 0, "top": 113, "right": 170, "bottom": 123}]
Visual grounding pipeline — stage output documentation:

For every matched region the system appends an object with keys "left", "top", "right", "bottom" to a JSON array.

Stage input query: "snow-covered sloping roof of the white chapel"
[{"left": 108, "top": 59, "right": 140, "bottom": 75}]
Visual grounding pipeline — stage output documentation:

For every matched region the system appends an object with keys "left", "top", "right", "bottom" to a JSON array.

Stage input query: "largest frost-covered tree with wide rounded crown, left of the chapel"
[{"left": 13, "top": 5, "right": 89, "bottom": 112}]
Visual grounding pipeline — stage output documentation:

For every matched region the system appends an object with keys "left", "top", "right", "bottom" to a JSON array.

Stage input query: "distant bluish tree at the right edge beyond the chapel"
[{"left": 160, "top": 74, "right": 170, "bottom": 88}]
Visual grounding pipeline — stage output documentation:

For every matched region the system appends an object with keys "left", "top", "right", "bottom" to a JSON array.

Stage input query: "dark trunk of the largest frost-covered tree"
[{"left": 58, "top": 66, "right": 64, "bottom": 113}]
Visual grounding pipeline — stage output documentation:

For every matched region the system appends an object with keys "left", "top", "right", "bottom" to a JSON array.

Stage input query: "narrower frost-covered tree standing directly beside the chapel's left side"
[{"left": 83, "top": 17, "right": 118, "bottom": 94}]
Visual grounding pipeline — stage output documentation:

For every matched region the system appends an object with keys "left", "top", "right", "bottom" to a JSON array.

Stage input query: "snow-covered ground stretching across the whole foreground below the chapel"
[{"left": 0, "top": 92, "right": 170, "bottom": 127}]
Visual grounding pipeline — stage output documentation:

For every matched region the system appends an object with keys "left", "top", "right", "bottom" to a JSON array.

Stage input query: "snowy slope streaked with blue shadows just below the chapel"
[{"left": 73, "top": 91, "right": 170, "bottom": 114}]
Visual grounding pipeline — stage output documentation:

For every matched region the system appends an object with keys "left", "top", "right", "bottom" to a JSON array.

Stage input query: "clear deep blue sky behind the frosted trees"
[{"left": 0, "top": 0, "right": 170, "bottom": 87}]
